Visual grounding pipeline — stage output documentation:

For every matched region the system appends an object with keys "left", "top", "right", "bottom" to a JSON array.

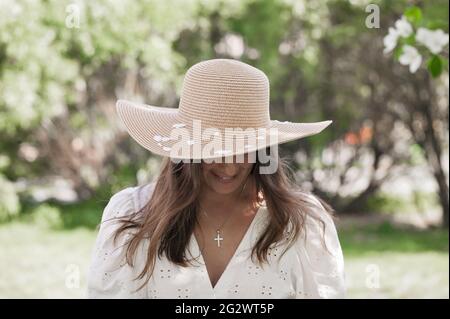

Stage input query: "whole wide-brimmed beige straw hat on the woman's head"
[{"left": 116, "top": 59, "right": 332, "bottom": 159}]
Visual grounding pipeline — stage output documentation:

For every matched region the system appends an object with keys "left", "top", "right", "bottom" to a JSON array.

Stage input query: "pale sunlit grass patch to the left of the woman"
[{"left": 0, "top": 223, "right": 95, "bottom": 298}]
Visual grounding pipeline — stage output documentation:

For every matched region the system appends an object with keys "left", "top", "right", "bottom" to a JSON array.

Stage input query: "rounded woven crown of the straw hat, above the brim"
[{"left": 179, "top": 59, "right": 270, "bottom": 129}]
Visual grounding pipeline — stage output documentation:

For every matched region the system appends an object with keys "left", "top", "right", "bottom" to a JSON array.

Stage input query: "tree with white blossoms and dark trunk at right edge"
[{"left": 384, "top": 1, "right": 449, "bottom": 228}]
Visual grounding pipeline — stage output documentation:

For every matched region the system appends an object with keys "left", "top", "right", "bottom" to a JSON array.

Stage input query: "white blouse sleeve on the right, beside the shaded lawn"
[{"left": 294, "top": 195, "right": 346, "bottom": 298}]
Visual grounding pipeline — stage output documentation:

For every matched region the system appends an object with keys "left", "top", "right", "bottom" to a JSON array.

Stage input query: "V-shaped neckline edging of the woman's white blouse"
[{"left": 191, "top": 205, "right": 265, "bottom": 292}]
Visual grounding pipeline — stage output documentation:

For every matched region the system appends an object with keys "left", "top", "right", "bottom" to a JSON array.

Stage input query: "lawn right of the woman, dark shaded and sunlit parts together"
[{"left": 339, "top": 221, "right": 449, "bottom": 298}]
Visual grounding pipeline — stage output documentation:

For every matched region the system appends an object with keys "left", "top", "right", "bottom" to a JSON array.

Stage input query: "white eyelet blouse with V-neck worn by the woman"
[{"left": 88, "top": 183, "right": 345, "bottom": 299}]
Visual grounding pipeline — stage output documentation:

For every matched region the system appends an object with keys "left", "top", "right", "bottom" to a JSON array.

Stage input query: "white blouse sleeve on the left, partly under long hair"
[{"left": 87, "top": 187, "right": 147, "bottom": 298}]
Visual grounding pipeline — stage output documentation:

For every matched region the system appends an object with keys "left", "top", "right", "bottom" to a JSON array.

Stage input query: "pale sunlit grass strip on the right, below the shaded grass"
[{"left": 344, "top": 252, "right": 449, "bottom": 298}]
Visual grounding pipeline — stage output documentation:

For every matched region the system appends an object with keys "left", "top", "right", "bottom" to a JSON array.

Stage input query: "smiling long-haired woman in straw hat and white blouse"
[{"left": 88, "top": 59, "right": 345, "bottom": 298}]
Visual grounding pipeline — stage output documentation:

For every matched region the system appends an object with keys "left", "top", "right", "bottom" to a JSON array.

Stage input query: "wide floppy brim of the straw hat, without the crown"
[{"left": 116, "top": 100, "right": 333, "bottom": 159}]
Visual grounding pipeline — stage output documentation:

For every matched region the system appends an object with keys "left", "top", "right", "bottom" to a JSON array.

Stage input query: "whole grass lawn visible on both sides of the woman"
[{"left": 0, "top": 216, "right": 449, "bottom": 298}]
